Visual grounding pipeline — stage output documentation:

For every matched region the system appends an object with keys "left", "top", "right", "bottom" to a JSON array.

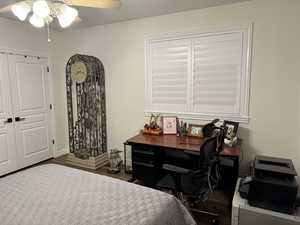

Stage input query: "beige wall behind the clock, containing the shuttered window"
[{"left": 53, "top": 0, "right": 300, "bottom": 173}]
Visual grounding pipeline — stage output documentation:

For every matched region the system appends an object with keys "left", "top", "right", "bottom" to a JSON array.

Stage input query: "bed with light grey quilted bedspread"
[{"left": 0, "top": 164, "right": 196, "bottom": 225}]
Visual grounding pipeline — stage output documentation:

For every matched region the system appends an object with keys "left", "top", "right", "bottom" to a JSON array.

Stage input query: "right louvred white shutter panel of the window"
[{"left": 192, "top": 33, "right": 243, "bottom": 114}]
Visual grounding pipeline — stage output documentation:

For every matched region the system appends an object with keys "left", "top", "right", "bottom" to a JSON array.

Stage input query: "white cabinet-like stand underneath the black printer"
[{"left": 231, "top": 179, "right": 300, "bottom": 225}]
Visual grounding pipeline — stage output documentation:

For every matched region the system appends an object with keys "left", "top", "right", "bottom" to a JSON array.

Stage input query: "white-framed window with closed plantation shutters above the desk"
[{"left": 145, "top": 26, "right": 251, "bottom": 122}]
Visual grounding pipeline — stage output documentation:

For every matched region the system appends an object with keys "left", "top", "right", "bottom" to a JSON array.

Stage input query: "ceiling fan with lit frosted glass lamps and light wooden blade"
[{"left": 0, "top": 0, "right": 121, "bottom": 30}]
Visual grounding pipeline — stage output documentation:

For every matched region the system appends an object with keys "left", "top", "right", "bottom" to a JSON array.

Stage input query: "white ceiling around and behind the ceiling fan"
[{"left": 0, "top": 0, "right": 247, "bottom": 28}]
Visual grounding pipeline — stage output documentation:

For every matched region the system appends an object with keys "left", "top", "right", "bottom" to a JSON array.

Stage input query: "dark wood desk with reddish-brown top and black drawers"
[{"left": 124, "top": 133, "right": 242, "bottom": 189}]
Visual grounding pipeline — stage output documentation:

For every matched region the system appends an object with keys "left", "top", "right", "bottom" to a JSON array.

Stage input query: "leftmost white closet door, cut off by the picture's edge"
[{"left": 0, "top": 54, "right": 17, "bottom": 176}]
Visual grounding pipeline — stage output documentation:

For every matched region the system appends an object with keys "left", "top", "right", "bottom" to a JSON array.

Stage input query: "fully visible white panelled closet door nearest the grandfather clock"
[{"left": 9, "top": 56, "right": 53, "bottom": 167}]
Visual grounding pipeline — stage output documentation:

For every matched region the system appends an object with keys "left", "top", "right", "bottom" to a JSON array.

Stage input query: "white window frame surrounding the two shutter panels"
[{"left": 144, "top": 23, "right": 253, "bottom": 124}]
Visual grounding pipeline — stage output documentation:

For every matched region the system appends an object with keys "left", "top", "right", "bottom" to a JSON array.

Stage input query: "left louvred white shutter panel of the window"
[{"left": 149, "top": 40, "right": 190, "bottom": 112}]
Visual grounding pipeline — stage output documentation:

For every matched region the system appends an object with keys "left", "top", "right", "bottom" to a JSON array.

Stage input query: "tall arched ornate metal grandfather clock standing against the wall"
[{"left": 66, "top": 55, "right": 108, "bottom": 170}]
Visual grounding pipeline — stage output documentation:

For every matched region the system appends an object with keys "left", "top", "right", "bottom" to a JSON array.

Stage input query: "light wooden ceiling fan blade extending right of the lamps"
[{"left": 68, "top": 0, "right": 121, "bottom": 8}]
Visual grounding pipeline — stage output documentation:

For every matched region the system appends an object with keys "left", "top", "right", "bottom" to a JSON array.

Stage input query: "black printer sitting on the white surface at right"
[{"left": 243, "top": 156, "right": 298, "bottom": 214}]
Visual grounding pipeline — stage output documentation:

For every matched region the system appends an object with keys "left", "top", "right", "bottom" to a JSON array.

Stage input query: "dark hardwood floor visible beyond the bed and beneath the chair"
[{"left": 37, "top": 155, "right": 231, "bottom": 225}]
